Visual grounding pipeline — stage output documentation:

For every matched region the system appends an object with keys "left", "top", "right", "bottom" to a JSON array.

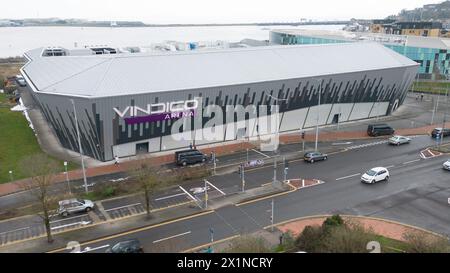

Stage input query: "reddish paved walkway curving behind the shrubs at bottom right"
[{"left": 277, "top": 215, "right": 444, "bottom": 241}]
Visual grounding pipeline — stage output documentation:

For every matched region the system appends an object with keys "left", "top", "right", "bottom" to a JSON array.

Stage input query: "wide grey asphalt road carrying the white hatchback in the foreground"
[{"left": 54, "top": 136, "right": 450, "bottom": 252}]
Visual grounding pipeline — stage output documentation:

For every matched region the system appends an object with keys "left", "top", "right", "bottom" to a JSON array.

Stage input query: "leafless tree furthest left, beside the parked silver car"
[{"left": 20, "top": 154, "right": 58, "bottom": 243}]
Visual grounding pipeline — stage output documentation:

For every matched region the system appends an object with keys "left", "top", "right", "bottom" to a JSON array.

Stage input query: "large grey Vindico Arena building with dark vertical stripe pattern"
[{"left": 21, "top": 43, "right": 418, "bottom": 161}]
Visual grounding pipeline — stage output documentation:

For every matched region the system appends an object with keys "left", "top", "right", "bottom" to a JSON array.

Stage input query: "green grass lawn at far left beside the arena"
[{"left": 0, "top": 94, "right": 76, "bottom": 183}]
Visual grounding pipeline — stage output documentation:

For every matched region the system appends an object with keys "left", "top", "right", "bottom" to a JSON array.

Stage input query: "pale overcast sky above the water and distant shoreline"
[{"left": 0, "top": 0, "right": 442, "bottom": 23}]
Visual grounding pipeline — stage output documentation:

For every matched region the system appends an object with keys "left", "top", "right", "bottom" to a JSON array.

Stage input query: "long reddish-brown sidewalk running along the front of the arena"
[{"left": 0, "top": 119, "right": 450, "bottom": 196}]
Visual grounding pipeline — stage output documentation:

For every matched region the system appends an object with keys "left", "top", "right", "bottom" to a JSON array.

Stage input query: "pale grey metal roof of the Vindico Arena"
[{"left": 23, "top": 42, "right": 417, "bottom": 97}]
